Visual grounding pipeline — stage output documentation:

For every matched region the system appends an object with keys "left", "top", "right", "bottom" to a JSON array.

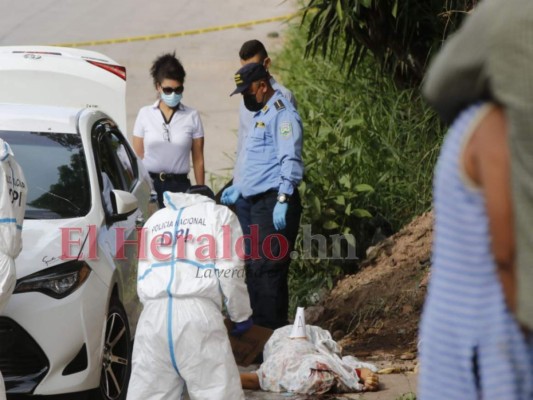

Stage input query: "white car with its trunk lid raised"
[{"left": 0, "top": 47, "right": 151, "bottom": 400}]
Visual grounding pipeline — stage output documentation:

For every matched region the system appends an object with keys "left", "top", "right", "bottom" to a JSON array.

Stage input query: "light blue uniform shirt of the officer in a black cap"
[{"left": 236, "top": 90, "right": 303, "bottom": 197}]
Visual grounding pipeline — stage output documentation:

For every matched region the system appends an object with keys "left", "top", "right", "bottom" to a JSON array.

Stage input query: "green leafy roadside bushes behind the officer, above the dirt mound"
[{"left": 275, "top": 21, "right": 443, "bottom": 310}]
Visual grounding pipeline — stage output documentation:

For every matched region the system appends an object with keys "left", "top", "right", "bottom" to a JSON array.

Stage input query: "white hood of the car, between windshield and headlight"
[{"left": 15, "top": 218, "right": 89, "bottom": 278}]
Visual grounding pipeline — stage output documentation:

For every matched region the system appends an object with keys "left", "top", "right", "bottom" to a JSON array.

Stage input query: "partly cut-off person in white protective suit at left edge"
[{"left": 0, "top": 139, "right": 28, "bottom": 400}]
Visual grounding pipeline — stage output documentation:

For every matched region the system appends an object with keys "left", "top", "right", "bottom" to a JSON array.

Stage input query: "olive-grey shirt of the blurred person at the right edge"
[{"left": 423, "top": 0, "right": 533, "bottom": 329}]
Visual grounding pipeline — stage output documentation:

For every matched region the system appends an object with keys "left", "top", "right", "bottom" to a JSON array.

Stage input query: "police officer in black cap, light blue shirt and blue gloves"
[{"left": 221, "top": 63, "right": 303, "bottom": 329}]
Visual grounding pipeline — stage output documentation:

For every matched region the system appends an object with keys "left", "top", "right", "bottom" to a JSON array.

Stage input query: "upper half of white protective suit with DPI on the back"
[{"left": 137, "top": 192, "right": 252, "bottom": 322}]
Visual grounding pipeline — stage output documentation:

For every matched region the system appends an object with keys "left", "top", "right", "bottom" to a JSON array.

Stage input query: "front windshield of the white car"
[{"left": 0, "top": 130, "right": 91, "bottom": 219}]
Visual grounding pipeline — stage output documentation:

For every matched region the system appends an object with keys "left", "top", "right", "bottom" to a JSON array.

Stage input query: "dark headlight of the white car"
[{"left": 13, "top": 261, "right": 91, "bottom": 299}]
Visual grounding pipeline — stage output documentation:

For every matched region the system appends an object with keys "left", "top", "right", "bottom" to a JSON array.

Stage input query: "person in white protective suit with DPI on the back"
[{"left": 127, "top": 186, "right": 252, "bottom": 400}]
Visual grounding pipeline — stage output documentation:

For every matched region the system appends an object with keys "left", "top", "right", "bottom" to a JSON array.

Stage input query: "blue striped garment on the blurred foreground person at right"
[{"left": 418, "top": 105, "right": 533, "bottom": 400}]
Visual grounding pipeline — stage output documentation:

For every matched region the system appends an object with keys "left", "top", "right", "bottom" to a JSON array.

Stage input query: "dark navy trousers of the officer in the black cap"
[{"left": 246, "top": 191, "right": 302, "bottom": 329}]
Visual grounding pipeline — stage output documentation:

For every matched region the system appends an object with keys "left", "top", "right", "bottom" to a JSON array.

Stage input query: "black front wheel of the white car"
[{"left": 100, "top": 298, "right": 133, "bottom": 400}]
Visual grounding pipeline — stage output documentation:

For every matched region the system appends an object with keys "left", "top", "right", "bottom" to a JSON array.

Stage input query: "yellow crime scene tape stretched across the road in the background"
[{"left": 52, "top": 13, "right": 300, "bottom": 47}]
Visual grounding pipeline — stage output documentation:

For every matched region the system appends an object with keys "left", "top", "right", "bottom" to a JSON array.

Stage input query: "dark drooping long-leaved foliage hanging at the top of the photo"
[{"left": 303, "top": 0, "right": 478, "bottom": 86}]
